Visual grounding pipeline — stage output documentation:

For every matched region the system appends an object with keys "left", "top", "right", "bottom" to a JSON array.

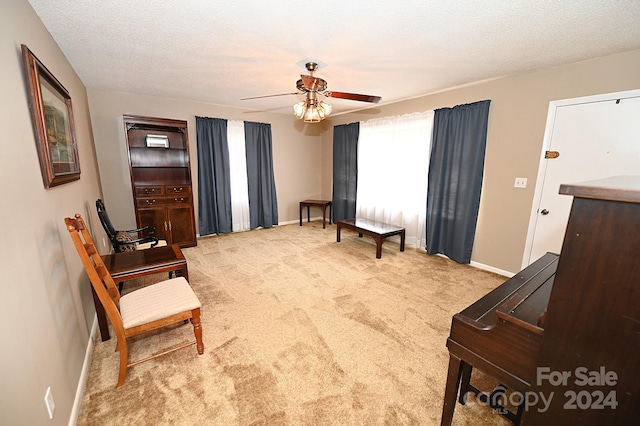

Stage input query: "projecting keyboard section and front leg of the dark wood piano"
[{"left": 442, "top": 253, "right": 559, "bottom": 425}]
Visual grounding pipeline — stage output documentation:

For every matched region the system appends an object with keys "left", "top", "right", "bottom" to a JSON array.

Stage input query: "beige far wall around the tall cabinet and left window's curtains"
[{"left": 88, "top": 89, "right": 326, "bottom": 229}]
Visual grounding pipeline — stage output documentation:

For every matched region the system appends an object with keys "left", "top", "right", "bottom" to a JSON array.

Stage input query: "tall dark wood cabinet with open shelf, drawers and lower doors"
[{"left": 123, "top": 115, "right": 197, "bottom": 247}]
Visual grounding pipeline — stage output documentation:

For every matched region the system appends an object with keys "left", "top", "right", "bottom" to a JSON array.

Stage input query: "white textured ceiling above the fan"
[{"left": 29, "top": 0, "right": 640, "bottom": 114}]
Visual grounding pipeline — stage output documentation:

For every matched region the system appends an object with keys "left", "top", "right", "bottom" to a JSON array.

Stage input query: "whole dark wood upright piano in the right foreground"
[{"left": 442, "top": 176, "right": 640, "bottom": 425}]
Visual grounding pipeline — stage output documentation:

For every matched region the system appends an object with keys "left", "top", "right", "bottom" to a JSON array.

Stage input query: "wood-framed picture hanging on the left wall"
[{"left": 21, "top": 44, "right": 80, "bottom": 188}]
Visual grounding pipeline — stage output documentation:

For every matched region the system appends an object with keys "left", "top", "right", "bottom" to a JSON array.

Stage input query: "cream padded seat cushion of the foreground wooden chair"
[{"left": 120, "top": 277, "right": 201, "bottom": 329}]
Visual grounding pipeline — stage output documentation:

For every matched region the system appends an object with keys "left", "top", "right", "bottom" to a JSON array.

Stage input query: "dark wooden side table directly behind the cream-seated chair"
[{"left": 91, "top": 244, "right": 189, "bottom": 342}]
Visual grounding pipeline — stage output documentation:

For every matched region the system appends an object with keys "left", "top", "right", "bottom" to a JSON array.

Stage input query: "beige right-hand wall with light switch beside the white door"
[{"left": 322, "top": 50, "right": 640, "bottom": 272}]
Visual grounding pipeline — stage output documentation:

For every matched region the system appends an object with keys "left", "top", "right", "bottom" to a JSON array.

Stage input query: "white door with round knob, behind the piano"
[{"left": 523, "top": 91, "right": 640, "bottom": 266}]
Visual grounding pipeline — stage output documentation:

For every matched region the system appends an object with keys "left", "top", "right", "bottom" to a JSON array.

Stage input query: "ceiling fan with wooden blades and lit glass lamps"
[{"left": 241, "top": 62, "right": 382, "bottom": 123}]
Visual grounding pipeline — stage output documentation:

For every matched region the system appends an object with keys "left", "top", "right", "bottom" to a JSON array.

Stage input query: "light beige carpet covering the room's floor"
[{"left": 78, "top": 222, "right": 509, "bottom": 425}]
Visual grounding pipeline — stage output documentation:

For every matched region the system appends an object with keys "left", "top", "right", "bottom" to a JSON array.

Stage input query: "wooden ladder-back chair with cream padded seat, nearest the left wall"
[{"left": 64, "top": 214, "right": 204, "bottom": 387}]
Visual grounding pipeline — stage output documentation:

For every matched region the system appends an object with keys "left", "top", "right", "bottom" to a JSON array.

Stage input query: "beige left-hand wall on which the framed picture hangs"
[{"left": 0, "top": 0, "right": 103, "bottom": 425}]
